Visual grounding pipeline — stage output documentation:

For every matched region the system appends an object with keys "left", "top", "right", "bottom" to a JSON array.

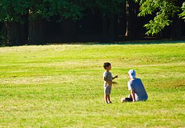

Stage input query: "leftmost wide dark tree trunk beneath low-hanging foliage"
[{"left": 5, "top": 22, "right": 25, "bottom": 46}]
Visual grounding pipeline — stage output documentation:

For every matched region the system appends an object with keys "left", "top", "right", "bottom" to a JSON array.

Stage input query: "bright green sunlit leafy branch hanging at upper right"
[{"left": 136, "top": 0, "right": 184, "bottom": 35}]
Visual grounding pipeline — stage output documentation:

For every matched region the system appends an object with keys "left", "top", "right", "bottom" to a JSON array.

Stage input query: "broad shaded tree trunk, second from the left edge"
[{"left": 28, "top": 10, "right": 44, "bottom": 45}]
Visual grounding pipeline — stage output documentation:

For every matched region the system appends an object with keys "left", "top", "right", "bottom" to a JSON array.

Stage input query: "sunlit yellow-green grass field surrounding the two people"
[{"left": 0, "top": 43, "right": 185, "bottom": 128}]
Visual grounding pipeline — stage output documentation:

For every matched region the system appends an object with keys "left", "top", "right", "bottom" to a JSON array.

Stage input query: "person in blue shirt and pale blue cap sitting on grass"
[{"left": 121, "top": 69, "right": 148, "bottom": 102}]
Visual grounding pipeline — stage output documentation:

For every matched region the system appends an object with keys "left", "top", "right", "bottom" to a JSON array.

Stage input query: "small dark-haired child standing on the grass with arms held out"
[{"left": 103, "top": 62, "right": 118, "bottom": 104}]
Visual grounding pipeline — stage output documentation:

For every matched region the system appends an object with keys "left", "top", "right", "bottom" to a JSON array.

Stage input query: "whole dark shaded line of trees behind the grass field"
[{"left": 0, "top": 0, "right": 185, "bottom": 46}]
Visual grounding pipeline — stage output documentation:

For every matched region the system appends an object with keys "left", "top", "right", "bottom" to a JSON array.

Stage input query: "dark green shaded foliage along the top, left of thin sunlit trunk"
[{"left": 0, "top": 0, "right": 124, "bottom": 22}]
